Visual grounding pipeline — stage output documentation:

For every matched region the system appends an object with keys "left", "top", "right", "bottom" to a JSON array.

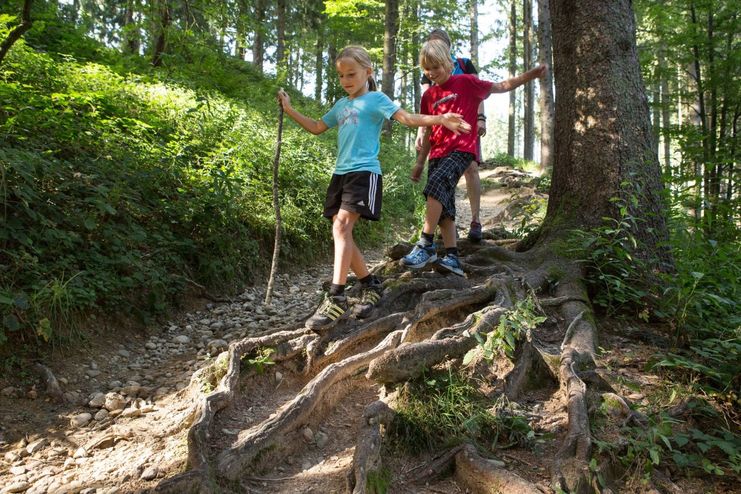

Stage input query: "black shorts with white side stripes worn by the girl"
[{"left": 324, "top": 172, "right": 383, "bottom": 221}]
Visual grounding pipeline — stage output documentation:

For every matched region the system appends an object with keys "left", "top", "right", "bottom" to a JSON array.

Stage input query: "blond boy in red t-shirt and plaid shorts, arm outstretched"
[{"left": 401, "top": 39, "right": 546, "bottom": 276}]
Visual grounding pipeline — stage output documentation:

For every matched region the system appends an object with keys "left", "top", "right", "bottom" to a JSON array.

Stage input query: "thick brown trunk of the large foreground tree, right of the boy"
[{"left": 542, "top": 0, "right": 672, "bottom": 269}]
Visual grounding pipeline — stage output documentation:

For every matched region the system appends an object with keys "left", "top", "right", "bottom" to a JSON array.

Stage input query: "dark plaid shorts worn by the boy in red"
[{"left": 422, "top": 151, "right": 476, "bottom": 221}]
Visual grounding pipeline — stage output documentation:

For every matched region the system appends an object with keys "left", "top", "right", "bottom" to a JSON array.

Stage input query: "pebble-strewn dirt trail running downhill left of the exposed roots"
[{"left": 0, "top": 165, "right": 536, "bottom": 494}]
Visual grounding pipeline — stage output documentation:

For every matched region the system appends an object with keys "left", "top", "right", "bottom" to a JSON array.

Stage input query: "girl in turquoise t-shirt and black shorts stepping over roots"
[{"left": 278, "top": 46, "right": 471, "bottom": 329}]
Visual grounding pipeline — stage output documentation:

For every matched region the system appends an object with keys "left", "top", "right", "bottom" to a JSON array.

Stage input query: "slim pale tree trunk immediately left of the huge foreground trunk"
[{"left": 538, "top": 0, "right": 555, "bottom": 172}]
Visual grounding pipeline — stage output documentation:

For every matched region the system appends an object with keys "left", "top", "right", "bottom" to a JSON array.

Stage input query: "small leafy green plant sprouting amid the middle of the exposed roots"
[{"left": 463, "top": 296, "right": 547, "bottom": 365}]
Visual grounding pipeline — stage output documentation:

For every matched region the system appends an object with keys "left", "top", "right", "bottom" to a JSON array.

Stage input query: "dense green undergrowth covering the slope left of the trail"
[{"left": 0, "top": 18, "right": 421, "bottom": 354}]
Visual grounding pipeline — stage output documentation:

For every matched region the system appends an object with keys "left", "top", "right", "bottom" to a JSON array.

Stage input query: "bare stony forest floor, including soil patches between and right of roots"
[{"left": 0, "top": 164, "right": 739, "bottom": 494}]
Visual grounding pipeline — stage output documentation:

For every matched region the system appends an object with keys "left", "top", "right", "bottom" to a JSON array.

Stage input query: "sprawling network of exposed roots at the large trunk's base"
[{"left": 159, "top": 237, "right": 612, "bottom": 493}]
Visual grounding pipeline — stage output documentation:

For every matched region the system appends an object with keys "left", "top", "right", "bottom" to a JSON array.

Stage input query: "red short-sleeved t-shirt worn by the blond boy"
[{"left": 420, "top": 74, "right": 494, "bottom": 159}]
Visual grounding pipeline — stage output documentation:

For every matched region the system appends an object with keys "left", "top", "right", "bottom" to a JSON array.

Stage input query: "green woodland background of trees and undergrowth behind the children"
[{"left": 0, "top": 0, "right": 741, "bottom": 482}]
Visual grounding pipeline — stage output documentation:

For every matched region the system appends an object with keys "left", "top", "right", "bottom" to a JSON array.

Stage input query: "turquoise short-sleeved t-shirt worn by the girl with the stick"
[{"left": 322, "top": 91, "right": 399, "bottom": 175}]
